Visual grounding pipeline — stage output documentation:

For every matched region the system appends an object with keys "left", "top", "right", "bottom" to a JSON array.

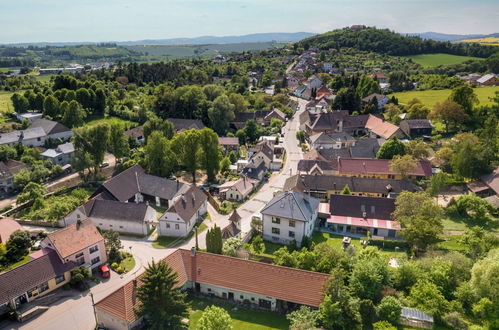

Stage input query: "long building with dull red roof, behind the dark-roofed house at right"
[{"left": 338, "top": 158, "right": 432, "bottom": 180}]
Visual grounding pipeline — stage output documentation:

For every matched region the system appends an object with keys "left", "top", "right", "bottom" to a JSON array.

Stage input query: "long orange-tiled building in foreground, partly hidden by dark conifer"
[{"left": 94, "top": 249, "right": 330, "bottom": 330}]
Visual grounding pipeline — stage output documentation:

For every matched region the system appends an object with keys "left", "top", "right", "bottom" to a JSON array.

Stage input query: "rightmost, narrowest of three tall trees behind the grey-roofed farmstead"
[{"left": 199, "top": 128, "right": 222, "bottom": 182}]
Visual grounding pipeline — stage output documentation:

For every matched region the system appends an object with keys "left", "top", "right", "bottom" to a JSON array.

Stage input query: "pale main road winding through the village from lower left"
[{"left": 7, "top": 99, "right": 307, "bottom": 330}]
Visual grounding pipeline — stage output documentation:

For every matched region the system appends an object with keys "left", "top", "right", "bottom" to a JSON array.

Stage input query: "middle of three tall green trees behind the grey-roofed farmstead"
[{"left": 172, "top": 129, "right": 202, "bottom": 185}]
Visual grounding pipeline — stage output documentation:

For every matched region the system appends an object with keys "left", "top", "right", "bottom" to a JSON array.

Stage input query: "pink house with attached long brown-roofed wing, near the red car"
[{"left": 0, "top": 220, "right": 107, "bottom": 314}]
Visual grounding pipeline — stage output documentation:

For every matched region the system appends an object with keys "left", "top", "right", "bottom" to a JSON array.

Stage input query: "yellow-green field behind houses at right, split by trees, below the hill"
[{"left": 390, "top": 86, "right": 499, "bottom": 108}]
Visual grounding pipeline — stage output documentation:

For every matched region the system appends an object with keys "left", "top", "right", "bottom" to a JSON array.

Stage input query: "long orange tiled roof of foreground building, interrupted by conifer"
[{"left": 95, "top": 249, "right": 330, "bottom": 323}]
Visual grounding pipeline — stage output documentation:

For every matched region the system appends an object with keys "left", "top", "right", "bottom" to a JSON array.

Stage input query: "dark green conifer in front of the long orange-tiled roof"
[{"left": 135, "top": 260, "right": 189, "bottom": 330}]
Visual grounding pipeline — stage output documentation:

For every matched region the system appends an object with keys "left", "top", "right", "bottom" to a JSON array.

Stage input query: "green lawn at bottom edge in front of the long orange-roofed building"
[{"left": 189, "top": 297, "right": 289, "bottom": 330}]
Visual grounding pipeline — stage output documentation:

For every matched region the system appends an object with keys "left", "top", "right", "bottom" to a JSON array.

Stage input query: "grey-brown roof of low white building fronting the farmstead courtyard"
[{"left": 79, "top": 199, "right": 151, "bottom": 223}]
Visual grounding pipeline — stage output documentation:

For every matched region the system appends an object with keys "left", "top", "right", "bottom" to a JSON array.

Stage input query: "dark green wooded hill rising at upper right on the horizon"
[{"left": 298, "top": 27, "right": 497, "bottom": 57}]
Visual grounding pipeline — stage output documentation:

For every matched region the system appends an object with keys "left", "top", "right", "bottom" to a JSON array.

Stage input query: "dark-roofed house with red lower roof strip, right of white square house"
[{"left": 326, "top": 195, "right": 401, "bottom": 239}]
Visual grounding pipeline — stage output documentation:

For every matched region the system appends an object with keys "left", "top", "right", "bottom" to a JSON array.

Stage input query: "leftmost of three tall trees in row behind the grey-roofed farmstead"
[{"left": 144, "top": 131, "right": 176, "bottom": 178}]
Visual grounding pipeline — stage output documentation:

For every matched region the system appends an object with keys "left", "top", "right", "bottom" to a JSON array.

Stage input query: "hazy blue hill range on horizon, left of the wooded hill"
[{"left": 3, "top": 32, "right": 315, "bottom": 47}]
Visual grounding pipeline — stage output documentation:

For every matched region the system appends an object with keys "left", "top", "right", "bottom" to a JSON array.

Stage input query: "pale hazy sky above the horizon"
[{"left": 0, "top": 0, "right": 499, "bottom": 43}]
